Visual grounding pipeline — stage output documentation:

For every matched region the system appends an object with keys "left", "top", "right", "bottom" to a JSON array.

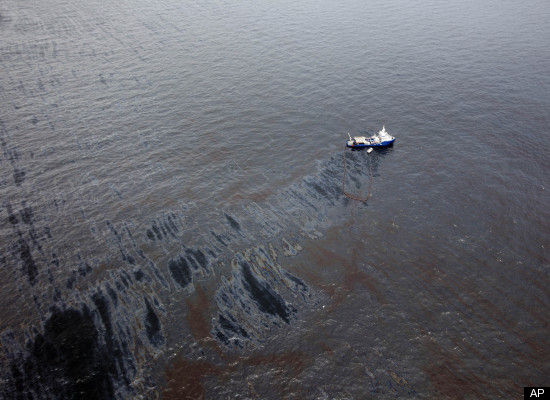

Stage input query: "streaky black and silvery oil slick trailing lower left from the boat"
[{"left": 0, "top": 148, "right": 380, "bottom": 399}]
